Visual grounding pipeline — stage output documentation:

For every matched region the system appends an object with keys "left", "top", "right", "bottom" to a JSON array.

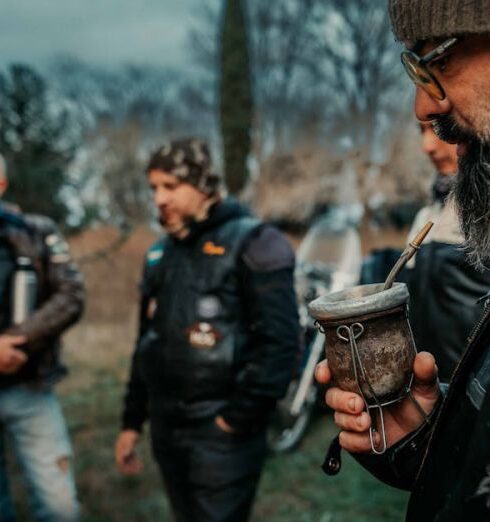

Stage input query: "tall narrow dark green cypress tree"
[{"left": 219, "top": 0, "right": 253, "bottom": 194}]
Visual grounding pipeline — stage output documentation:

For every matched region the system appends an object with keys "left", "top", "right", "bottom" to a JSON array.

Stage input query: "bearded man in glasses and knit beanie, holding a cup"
[{"left": 317, "top": 0, "right": 490, "bottom": 522}]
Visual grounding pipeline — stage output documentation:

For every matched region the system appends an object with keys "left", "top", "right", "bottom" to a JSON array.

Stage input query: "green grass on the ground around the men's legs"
[{"left": 9, "top": 358, "right": 407, "bottom": 522}]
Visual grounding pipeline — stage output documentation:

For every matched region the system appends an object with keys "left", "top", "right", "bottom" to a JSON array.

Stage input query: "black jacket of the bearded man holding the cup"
[{"left": 354, "top": 307, "right": 490, "bottom": 522}]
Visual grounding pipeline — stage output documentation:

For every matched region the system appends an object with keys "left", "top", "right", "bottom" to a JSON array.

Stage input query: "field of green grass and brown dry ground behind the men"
[{"left": 10, "top": 225, "right": 407, "bottom": 522}]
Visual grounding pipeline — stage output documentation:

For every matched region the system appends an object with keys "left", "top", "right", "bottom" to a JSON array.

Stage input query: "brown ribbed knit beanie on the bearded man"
[{"left": 389, "top": 0, "right": 490, "bottom": 43}]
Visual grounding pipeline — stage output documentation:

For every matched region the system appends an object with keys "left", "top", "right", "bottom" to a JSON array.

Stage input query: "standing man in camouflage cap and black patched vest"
[{"left": 115, "top": 139, "right": 300, "bottom": 522}]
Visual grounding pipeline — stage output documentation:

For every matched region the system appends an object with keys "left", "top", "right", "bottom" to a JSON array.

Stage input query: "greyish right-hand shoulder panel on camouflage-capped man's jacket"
[{"left": 242, "top": 224, "right": 295, "bottom": 272}]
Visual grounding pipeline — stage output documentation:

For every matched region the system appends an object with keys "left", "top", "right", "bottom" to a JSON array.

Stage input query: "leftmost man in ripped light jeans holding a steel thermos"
[{"left": 0, "top": 156, "right": 84, "bottom": 522}]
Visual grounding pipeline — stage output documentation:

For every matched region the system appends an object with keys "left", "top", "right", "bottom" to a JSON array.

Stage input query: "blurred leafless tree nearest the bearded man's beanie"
[{"left": 311, "top": 0, "right": 411, "bottom": 163}]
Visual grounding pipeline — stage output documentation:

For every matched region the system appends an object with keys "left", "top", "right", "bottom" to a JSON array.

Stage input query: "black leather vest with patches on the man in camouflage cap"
[{"left": 138, "top": 211, "right": 261, "bottom": 418}]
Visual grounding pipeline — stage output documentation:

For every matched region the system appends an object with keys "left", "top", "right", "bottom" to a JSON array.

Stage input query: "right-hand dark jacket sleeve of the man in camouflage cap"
[{"left": 221, "top": 225, "right": 301, "bottom": 432}]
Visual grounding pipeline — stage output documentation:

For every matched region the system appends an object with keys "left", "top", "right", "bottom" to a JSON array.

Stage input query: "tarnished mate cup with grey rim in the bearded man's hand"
[{"left": 310, "top": 283, "right": 416, "bottom": 404}]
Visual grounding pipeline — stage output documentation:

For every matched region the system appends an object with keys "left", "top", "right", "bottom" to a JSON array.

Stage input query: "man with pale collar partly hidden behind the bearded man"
[{"left": 402, "top": 122, "right": 490, "bottom": 382}]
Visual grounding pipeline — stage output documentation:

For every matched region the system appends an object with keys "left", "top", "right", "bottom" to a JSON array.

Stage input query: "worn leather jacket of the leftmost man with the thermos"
[{"left": 0, "top": 204, "right": 84, "bottom": 388}]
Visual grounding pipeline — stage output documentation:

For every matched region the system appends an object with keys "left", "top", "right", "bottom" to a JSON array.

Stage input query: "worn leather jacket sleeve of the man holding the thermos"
[{"left": 9, "top": 217, "right": 85, "bottom": 353}]
